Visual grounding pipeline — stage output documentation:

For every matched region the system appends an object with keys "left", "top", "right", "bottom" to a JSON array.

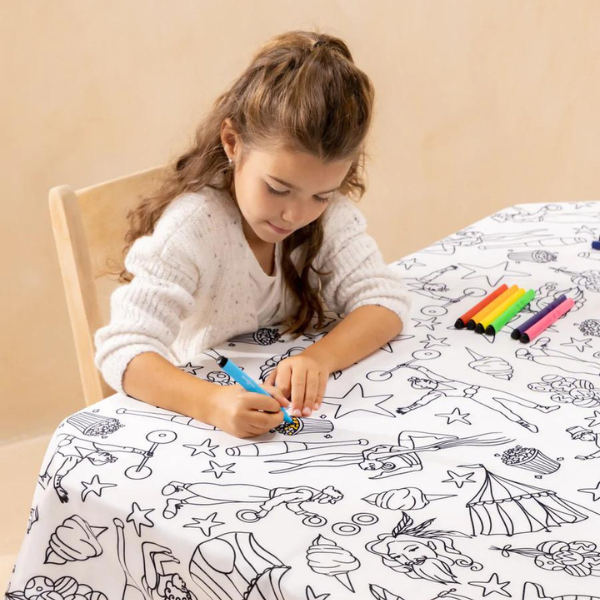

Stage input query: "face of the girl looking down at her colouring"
[{"left": 229, "top": 144, "right": 352, "bottom": 244}]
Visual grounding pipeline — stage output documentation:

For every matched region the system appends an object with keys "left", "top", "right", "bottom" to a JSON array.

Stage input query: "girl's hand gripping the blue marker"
[{"left": 210, "top": 385, "right": 290, "bottom": 438}]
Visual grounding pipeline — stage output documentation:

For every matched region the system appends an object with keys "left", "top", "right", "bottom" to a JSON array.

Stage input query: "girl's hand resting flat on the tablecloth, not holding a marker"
[{"left": 266, "top": 354, "right": 330, "bottom": 417}]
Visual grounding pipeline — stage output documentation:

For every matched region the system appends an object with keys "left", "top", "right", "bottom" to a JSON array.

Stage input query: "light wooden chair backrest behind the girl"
[{"left": 49, "top": 166, "right": 166, "bottom": 406}]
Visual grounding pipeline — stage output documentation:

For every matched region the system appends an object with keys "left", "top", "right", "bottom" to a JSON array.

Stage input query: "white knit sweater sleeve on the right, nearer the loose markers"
[{"left": 315, "top": 196, "right": 411, "bottom": 327}]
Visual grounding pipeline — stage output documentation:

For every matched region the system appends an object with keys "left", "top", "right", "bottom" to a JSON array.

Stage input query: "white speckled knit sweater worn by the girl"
[{"left": 95, "top": 187, "right": 410, "bottom": 393}]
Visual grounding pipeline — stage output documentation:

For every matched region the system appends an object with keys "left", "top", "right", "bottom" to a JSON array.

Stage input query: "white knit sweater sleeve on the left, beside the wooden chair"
[{"left": 94, "top": 204, "right": 200, "bottom": 394}]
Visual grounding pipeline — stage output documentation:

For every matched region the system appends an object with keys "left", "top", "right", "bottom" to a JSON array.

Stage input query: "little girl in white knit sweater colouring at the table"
[{"left": 95, "top": 31, "right": 409, "bottom": 438}]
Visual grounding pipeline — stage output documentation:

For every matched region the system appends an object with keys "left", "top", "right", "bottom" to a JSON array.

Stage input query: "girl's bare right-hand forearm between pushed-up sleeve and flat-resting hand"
[{"left": 302, "top": 305, "right": 403, "bottom": 373}]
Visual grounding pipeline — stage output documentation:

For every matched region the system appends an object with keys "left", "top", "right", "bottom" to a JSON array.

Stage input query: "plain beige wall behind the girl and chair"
[{"left": 0, "top": 0, "right": 600, "bottom": 443}]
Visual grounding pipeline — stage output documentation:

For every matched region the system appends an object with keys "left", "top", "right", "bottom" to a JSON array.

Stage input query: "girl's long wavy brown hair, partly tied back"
[{"left": 119, "top": 31, "right": 374, "bottom": 333}]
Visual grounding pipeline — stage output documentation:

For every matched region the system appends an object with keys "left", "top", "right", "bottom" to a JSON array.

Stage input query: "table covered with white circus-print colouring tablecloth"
[{"left": 7, "top": 202, "right": 600, "bottom": 600}]
